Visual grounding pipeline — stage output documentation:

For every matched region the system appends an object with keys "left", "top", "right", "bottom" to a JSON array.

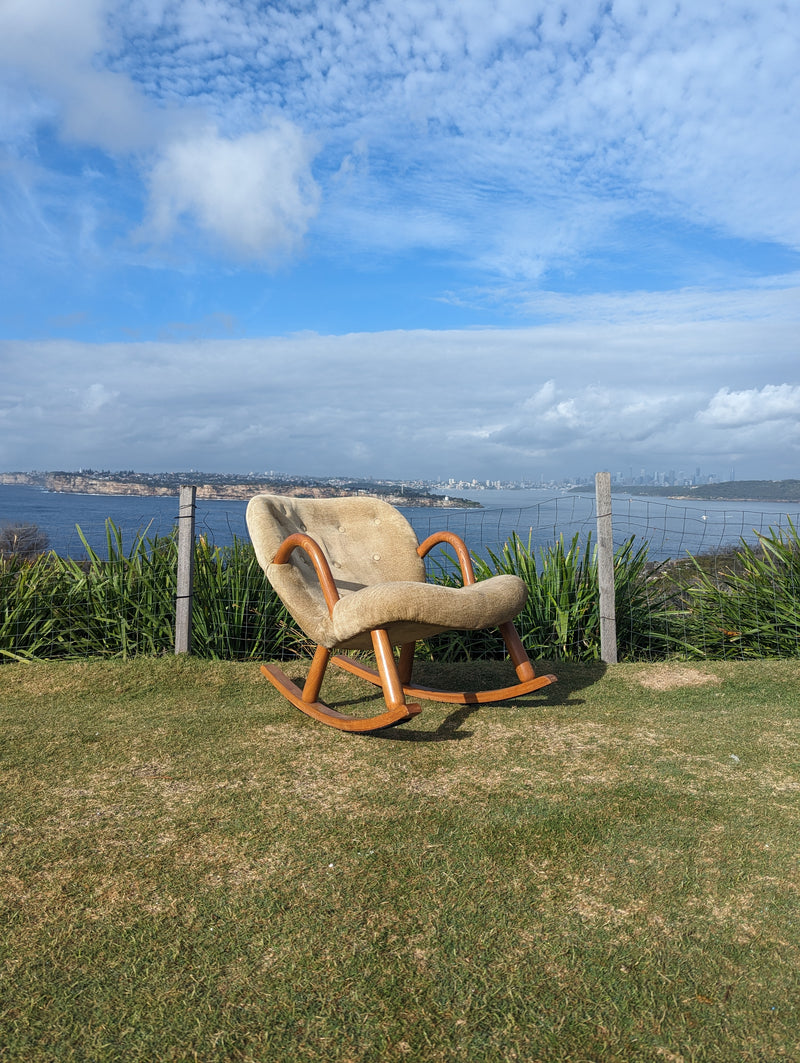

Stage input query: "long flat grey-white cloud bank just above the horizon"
[{"left": 0, "top": 291, "right": 800, "bottom": 478}]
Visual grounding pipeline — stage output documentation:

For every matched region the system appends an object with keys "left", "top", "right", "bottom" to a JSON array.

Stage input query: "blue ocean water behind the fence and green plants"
[{"left": 0, "top": 485, "right": 800, "bottom": 560}]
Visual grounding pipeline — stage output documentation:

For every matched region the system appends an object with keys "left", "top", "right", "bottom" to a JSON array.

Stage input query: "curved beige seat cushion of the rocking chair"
[{"left": 331, "top": 575, "right": 528, "bottom": 647}]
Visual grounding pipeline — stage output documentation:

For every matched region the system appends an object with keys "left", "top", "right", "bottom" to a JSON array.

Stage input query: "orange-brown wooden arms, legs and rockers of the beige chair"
[{"left": 261, "top": 532, "right": 556, "bottom": 732}]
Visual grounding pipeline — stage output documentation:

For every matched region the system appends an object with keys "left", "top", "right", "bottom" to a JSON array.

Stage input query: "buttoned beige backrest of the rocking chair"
[{"left": 246, "top": 494, "right": 425, "bottom": 643}]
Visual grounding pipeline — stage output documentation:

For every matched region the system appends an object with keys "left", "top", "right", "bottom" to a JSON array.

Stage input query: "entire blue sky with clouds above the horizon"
[{"left": 0, "top": 0, "right": 800, "bottom": 479}]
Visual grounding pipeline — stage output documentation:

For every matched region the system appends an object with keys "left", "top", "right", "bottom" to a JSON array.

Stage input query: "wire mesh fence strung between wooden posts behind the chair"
[{"left": 0, "top": 489, "right": 800, "bottom": 660}]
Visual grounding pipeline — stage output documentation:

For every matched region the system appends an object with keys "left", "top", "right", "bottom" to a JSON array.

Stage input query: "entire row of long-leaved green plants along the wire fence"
[{"left": 0, "top": 521, "right": 800, "bottom": 661}]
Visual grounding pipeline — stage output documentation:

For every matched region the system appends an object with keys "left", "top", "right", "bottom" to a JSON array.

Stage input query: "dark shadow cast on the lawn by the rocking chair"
[{"left": 337, "top": 661, "right": 607, "bottom": 742}]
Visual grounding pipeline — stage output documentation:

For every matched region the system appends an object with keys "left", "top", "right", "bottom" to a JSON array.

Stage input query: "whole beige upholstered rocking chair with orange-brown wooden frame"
[{"left": 248, "top": 494, "right": 556, "bottom": 731}]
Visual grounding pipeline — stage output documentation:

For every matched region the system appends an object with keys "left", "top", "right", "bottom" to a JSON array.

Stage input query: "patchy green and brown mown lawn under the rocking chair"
[{"left": 0, "top": 658, "right": 800, "bottom": 1063}]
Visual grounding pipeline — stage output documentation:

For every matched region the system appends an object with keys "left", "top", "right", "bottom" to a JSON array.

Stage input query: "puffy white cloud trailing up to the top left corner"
[{"left": 0, "top": 0, "right": 319, "bottom": 258}]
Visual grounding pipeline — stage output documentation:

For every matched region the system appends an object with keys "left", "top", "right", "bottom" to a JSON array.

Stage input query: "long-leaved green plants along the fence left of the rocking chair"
[{"left": 0, "top": 521, "right": 303, "bottom": 661}]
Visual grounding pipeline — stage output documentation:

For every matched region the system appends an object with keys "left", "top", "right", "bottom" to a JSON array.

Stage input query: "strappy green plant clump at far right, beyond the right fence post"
[{"left": 664, "top": 519, "right": 800, "bottom": 659}]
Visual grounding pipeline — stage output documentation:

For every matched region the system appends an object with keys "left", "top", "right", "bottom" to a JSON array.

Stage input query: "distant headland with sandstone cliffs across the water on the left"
[{"left": 0, "top": 469, "right": 480, "bottom": 509}]
